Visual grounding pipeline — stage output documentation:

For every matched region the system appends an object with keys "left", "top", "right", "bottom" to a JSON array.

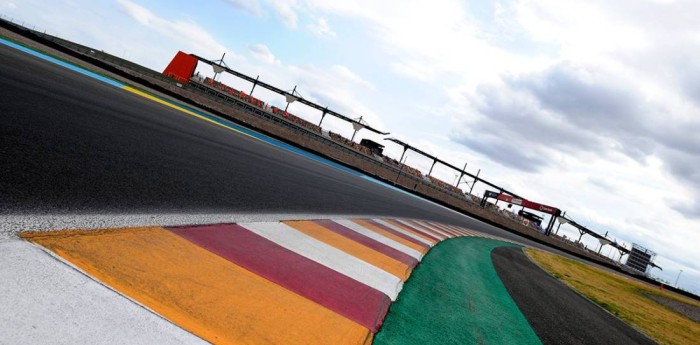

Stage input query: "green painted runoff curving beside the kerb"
[{"left": 373, "top": 237, "right": 542, "bottom": 345}]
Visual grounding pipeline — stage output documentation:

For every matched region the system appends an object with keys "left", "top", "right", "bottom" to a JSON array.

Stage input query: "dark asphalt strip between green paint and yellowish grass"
[{"left": 491, "top": 247, "right": 655, "bottom": 344}]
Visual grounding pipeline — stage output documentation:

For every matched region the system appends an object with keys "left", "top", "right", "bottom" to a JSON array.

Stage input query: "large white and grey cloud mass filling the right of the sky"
[{"left": 300, "top": 0, "right": 700, "bottom": 290}]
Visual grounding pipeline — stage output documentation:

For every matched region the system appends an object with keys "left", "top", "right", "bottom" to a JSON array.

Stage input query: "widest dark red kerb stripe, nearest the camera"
[{"left": 169, "top": 224, "right": 391, "bottom": 332}]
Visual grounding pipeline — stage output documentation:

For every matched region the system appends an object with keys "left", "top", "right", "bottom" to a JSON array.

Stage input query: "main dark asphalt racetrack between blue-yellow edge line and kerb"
[{"left": 0, "top": 46, "right": 492, "bottom": 228}]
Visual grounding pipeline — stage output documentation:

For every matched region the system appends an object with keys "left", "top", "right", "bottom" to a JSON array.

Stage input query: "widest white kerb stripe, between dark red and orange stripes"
[{"left": 238, "top": 222, "right": 403, "bottom": 301}]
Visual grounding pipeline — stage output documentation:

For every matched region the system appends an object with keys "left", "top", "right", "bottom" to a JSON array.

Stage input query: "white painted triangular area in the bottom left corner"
[{"left": 0, "top": 240, "right": 208, "bottom": 344}]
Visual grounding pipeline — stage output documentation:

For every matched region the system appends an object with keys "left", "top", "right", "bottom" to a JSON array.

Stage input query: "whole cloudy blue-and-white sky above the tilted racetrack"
[{"left": 0, "top": 0, "right": 700, "bottom": 294}]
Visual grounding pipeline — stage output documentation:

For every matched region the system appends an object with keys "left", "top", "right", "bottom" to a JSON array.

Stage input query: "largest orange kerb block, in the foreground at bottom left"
[{"left": 23, "top": 227, "right": 372, "bottom": 345}]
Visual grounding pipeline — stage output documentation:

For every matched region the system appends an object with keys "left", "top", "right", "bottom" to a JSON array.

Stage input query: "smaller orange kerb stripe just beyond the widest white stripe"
[{"left": 283, "top": 221, "right": 411, "bottom": 281}]
